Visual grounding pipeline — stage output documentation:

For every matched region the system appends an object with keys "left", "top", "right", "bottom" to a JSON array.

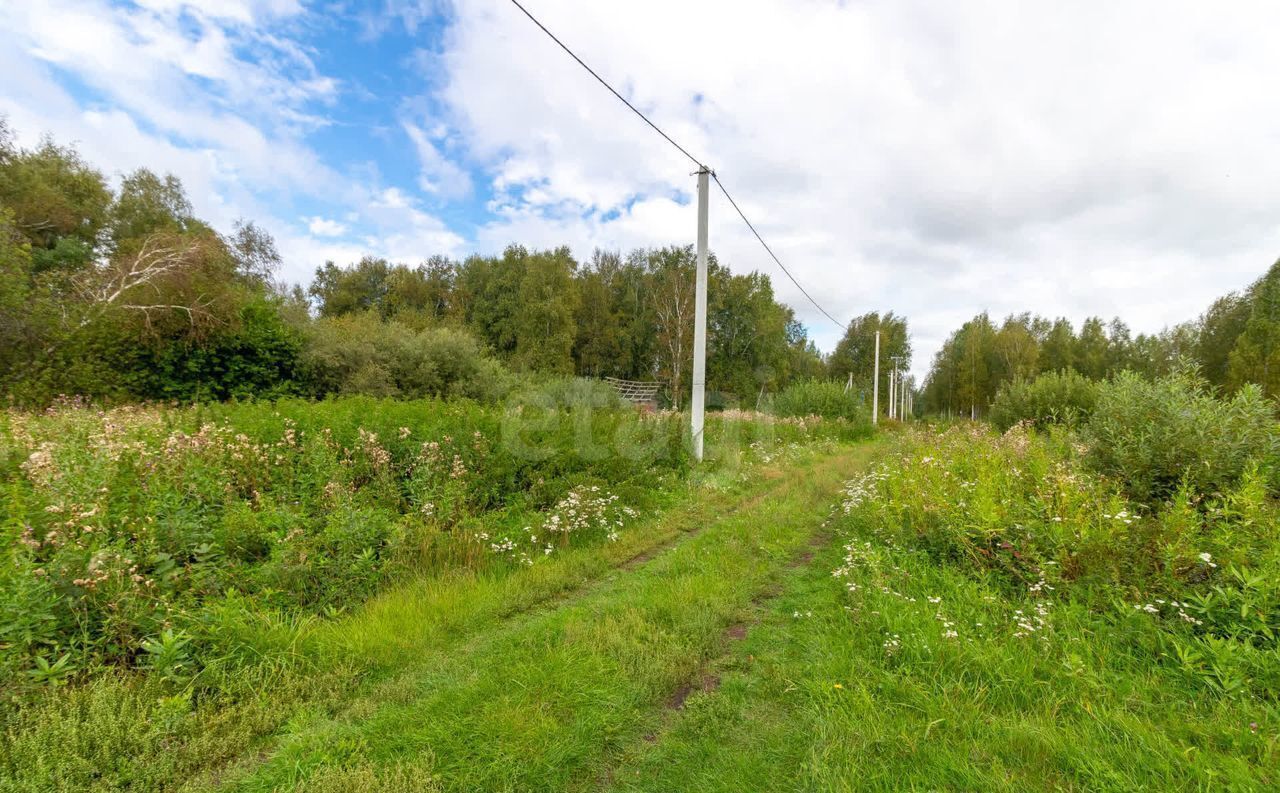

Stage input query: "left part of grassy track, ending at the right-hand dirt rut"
[{"left": 204, "top": 446, "right": 868, "bottom": 790}]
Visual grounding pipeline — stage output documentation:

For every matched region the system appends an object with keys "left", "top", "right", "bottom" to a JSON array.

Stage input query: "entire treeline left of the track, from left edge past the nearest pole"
[{"left": 0, "top": 124, "right": 827, "bottom": 407}]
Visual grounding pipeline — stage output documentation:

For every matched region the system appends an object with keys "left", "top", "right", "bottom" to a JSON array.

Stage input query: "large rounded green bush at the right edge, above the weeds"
[{"left": 1084, "top": 371, "right": 1276, "bottom": 501}]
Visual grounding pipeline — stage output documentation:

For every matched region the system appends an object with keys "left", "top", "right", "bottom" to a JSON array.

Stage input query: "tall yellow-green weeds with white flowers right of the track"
[{"left": 844, "top": 422, "right": 1280, "bottom": 697}]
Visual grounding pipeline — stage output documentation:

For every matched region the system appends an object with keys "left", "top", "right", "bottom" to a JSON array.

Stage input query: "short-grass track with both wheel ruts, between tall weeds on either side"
[{"left": 197, "top": 434, "right": 1280, "bottom": 793}]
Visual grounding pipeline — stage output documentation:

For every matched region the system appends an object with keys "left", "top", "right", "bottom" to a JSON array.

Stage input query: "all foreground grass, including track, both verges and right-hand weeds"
[{"left": 0, "top": 406, "right": 1280, "bottom": 793}]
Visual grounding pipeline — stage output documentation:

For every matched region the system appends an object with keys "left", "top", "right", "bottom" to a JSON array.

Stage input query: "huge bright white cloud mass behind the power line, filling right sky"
[{"left": 425, "top": 0, "right": 1280, "bottom": 373}]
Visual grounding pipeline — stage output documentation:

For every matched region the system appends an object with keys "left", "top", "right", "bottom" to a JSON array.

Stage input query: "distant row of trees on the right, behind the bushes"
[{"left": 920, "top": 261, "right": 1280, "bottom": 417}]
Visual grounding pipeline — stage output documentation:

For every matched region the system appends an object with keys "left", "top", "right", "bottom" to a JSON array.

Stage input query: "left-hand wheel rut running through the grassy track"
[{"left": 194, "top": 449, "right": 875, "bottom": 789}]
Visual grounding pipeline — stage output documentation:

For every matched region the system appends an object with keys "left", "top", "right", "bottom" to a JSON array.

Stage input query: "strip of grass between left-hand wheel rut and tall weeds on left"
[{"left": 0, "top": 416, "right": 860, "bottom": 790}]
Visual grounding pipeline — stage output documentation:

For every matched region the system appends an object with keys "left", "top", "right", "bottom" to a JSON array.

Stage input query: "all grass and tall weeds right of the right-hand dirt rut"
[{"left": 613, "top": 426, "right": 1280, "bottom": 790}]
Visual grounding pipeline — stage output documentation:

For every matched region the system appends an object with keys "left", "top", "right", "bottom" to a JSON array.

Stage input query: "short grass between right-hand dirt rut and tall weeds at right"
[{"left": 613, "top": 480, "right": 1280, "bottom": 793}]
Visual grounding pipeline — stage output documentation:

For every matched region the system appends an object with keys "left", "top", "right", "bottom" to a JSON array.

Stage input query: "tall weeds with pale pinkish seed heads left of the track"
[{"left": 0, "top": 393, "right": 846, "bottom": 691}]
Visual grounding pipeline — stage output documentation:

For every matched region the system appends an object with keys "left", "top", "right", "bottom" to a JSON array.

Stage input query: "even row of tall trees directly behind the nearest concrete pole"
[{"left": 307, "top": 246, "right": 824, "bottom": 404}]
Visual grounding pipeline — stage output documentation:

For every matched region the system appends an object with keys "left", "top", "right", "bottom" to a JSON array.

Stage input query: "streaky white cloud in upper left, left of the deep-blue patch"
[{"left": 0, "top": 0, "right": 462, "bottom": 287}]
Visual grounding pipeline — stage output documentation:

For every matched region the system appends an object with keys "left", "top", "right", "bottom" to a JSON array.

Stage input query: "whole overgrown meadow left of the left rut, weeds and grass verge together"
[{"left": 0, "top": 399, "right": 865, "bottom": 790}]
